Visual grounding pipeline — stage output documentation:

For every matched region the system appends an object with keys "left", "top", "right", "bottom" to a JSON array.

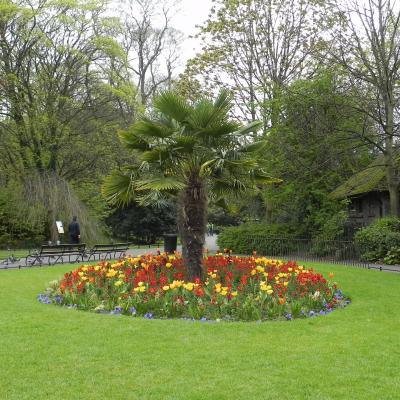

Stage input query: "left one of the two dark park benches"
[{"left": 25, "top": 243, "right": 86, "bottom": 266}]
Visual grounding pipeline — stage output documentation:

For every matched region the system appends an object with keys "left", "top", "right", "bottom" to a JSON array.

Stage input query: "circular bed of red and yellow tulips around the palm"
[{"left": 38, "top": 254, "right": 350, "bottom": 321}]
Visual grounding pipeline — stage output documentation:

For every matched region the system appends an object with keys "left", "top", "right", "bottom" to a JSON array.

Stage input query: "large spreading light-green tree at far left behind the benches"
[{"left": 0, "top": 0, "right": 132, "bottom": 240}]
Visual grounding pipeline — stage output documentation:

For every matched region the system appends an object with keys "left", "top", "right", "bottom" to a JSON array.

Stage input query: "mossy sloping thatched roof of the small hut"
[{"left": 331, "top": 154, "right": 392, "bottom": 199}]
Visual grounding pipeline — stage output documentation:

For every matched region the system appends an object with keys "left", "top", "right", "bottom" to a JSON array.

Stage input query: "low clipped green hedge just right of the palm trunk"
[{"left": 217, "top": 223, "right": 296, "bottom": 254}]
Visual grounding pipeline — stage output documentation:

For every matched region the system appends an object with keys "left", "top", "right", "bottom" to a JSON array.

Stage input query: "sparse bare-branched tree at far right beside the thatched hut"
[{"left": 331, "top": 0, "right": 400, "bottom": 216}]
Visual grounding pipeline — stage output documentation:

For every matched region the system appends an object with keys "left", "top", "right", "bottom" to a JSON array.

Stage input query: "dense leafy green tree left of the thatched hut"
[{"left": 262, "top": 69, "right": 373, "bottom": 239}]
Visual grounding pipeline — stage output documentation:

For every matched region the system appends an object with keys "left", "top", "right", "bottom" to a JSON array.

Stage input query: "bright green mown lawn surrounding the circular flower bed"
[{"left": 0, "top": 264, "right": 400, "bottom": 400}]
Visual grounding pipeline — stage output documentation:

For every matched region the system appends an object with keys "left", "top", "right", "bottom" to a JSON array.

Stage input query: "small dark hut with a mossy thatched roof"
[{"left": 331, "top": 156, "right": 392, "bottom": 227}]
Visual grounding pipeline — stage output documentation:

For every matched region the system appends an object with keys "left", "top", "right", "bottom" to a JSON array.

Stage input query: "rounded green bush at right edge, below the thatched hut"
[{"left": 355, "top": 217, "right": 400, "bottom": 262}]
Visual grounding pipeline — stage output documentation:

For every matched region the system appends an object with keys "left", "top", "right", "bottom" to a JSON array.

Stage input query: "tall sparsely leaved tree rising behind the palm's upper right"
[{"left": 183, "top": 0, "right": 322, "bottom": 134}]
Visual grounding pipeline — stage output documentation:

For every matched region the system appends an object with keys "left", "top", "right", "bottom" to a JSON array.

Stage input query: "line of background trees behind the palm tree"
[{"left": 0, "top": 0, "right": 400, "bottom": 247}]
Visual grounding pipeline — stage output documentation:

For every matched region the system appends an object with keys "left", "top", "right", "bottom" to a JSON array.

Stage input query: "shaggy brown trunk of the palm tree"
[{"left": 178, "top": 175, "right": 207, "bottom": 280}]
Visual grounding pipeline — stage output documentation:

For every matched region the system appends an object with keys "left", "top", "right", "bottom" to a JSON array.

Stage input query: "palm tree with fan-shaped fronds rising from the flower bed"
[{"left": 103, "top": 91, "right": 272, "bottom": 279}]
